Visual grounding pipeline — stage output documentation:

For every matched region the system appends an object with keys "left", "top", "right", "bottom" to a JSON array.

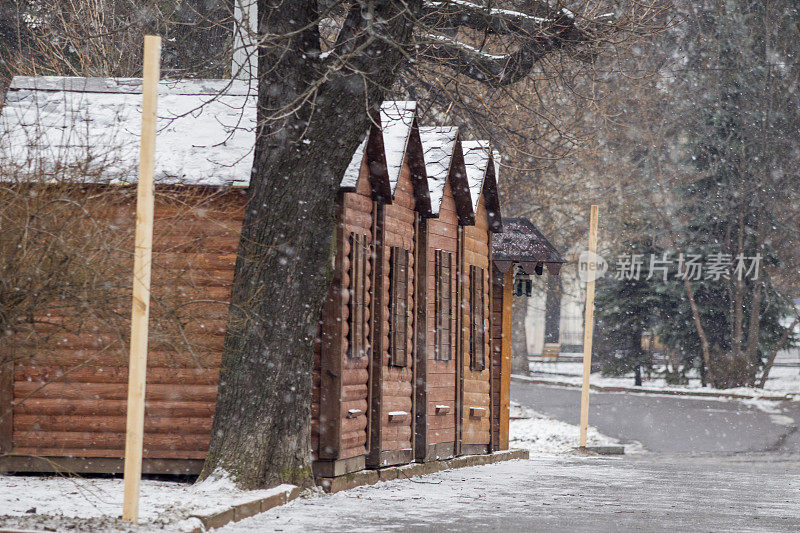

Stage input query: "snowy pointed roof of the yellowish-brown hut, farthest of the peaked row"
[{"left": 461, "top": 140, "right": 502, "bottom": 233}]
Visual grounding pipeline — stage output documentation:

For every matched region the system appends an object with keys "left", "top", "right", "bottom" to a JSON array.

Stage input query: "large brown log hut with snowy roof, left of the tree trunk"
[{"left": 0, "top": 77, "right": 255, "bottom": 473}]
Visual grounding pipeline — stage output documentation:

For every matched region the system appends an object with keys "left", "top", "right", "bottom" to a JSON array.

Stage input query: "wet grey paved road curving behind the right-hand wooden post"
[{"left": 511, "top": 381, "right": 800, "bottom": 453}]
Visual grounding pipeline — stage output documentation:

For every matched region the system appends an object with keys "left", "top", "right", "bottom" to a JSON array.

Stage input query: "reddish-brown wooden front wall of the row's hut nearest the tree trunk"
[{"left": 312, "top": 159, "right": 374, "bottom": 467}]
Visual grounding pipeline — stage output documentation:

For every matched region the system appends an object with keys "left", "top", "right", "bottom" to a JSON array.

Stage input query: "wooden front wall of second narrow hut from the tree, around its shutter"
[{"left": 370, "top": 161, "right": 416, "bottom": 465}]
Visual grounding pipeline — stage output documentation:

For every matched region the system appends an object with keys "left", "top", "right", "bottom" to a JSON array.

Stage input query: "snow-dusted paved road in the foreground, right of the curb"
[{"left": 219, "top": 454, "right": 800, "bottom": 533}]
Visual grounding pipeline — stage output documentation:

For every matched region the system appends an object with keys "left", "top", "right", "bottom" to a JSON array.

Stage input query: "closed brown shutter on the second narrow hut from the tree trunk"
[{"left": 389, "top": 246, "right": 408, "bottom": 366}]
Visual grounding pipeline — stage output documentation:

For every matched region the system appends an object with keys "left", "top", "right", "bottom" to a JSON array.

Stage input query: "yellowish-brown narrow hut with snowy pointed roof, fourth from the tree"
[{"left": 459, "top": 141, "right": 502, "bottom": 454}]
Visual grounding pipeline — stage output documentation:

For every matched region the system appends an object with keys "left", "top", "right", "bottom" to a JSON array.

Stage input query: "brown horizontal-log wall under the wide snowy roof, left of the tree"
[{"left": 3, "top": 190, "right": 245, "bottom": 459}]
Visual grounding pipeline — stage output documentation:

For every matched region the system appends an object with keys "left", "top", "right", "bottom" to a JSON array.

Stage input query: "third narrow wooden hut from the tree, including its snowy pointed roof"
[{"left": 414, "top": 127, "right": 474, "bottom": 461}]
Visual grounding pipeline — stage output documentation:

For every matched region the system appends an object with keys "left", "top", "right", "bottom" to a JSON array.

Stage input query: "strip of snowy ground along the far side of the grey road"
[{"left": 530, "top": 362, "right": 800, "bottom": 396}]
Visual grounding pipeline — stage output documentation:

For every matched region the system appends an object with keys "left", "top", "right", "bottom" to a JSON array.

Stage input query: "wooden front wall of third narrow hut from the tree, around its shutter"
[{"left": 423, "top": 180, "right": 458, "bottom": 458}]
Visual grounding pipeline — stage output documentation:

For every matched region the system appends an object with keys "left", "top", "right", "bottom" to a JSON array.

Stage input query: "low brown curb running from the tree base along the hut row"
[{"left": 188, "top": 450, "right": 530, "bottom": 533}]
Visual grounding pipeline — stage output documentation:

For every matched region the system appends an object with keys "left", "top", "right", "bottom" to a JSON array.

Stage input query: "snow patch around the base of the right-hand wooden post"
[{"left": 509, "top": 402, "right": 642, "bottom": 457}]
